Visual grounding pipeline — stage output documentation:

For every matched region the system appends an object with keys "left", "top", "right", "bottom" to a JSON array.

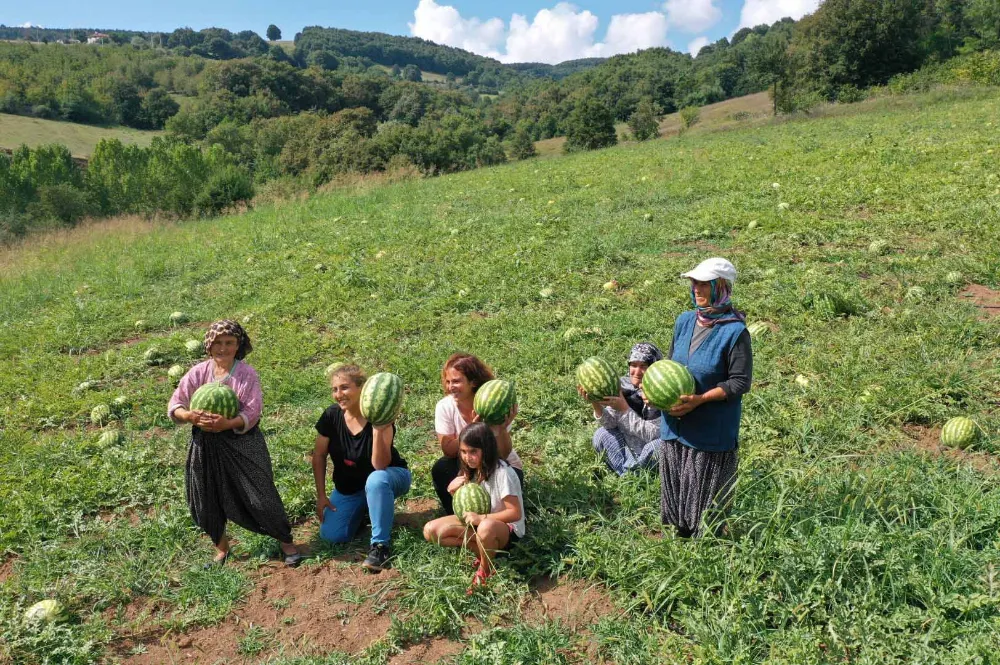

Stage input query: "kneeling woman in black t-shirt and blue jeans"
[{"left": 312, "top": 365, "right": 412, "bottom": 572}]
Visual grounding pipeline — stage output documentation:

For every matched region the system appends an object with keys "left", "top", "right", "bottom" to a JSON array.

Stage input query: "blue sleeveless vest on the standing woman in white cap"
[{"left": 660, "top": 310, "right": 746, "bottom": 452}]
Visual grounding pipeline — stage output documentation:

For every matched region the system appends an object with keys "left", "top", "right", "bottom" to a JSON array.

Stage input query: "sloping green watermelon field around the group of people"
[{"left": 0, "top": 89, "right": 1000, "bottom": 665}]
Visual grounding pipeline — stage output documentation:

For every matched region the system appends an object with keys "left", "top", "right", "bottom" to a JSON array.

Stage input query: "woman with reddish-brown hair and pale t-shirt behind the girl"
[{"left": 431, "top": 353, "right": 524, "bottom": 515}]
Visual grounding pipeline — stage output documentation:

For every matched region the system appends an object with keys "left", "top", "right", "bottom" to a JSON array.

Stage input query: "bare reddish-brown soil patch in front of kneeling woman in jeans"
[{"left": 116, "top": 561, "right": 399, "bottom": 665}]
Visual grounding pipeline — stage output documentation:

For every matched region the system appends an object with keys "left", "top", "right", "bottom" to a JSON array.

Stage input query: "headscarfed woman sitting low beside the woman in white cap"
[{"left": 577, "top": 342, "right": 663, "bottom": 476}]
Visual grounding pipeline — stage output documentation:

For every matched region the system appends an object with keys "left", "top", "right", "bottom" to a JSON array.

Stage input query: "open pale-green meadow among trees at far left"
[{"left": 0, "top": 113, "right": 162, "bottom": 157}]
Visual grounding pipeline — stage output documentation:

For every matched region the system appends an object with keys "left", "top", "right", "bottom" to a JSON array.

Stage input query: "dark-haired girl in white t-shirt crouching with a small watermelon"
[{"left": 424, "top": 423, "right": 525, "bottom": 593}]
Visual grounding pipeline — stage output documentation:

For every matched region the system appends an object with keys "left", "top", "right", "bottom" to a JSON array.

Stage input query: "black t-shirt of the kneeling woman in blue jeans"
[{"left": 316, "top": 404, "right": 408, "bottom": 494}]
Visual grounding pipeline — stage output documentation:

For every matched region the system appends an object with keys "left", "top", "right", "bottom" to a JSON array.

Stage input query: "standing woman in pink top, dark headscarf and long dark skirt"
[{"left": 167, "top": 320, "right": 302, "bottom": 566}]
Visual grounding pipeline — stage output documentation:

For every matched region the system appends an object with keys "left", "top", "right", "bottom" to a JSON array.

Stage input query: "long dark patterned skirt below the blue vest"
[{"left": 660, "top": 439, "right": 739, "bottom": 538}]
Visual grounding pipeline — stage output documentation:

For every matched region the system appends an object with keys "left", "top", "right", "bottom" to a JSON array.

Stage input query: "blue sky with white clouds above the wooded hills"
[{"left": 0, "top": 0, "right": 820, "bottom": 62}]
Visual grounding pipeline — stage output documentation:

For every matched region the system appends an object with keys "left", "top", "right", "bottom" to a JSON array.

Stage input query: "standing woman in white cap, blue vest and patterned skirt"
[{"left": 660, "top": 258, "right": 753, "bottom": 538}]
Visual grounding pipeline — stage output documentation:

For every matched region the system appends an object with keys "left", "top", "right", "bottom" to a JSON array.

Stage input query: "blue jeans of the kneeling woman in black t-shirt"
[{"left": 319, "top": 466, "right": 413, "bottom": 545}]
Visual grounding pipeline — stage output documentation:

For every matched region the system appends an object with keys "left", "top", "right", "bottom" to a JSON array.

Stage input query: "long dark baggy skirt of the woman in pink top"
[{"left": 184, "top": 427, "right": 292, "bottom": 545}]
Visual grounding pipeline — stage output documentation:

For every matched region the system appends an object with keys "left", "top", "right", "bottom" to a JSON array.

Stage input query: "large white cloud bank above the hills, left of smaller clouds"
[{"left": 409, "top": 0, "right": 667, "bottom": 64}]
